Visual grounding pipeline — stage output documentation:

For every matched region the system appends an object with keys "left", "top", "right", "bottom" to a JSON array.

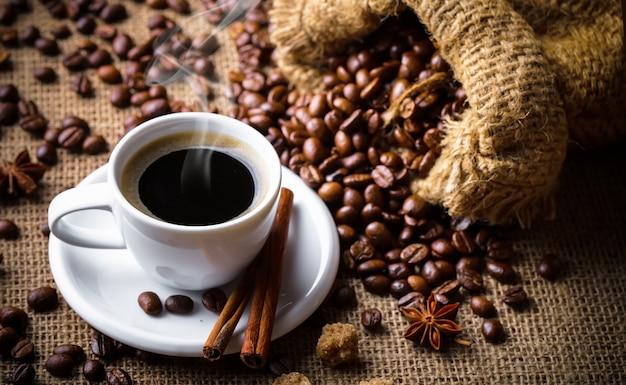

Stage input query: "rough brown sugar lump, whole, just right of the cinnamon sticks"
[{"left": 316, "top": 323, "right": 359, "bottom": 367}]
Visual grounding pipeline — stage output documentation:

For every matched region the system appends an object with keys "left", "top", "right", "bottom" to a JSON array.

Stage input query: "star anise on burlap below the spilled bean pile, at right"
[{"left": 402, "top": 294, "right": 463, "bottom": 350}]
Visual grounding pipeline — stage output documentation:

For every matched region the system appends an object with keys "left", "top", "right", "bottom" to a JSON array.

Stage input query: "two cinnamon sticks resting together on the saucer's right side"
[{"left": 202, "top": 187, "right": 293, "bottom": 368}]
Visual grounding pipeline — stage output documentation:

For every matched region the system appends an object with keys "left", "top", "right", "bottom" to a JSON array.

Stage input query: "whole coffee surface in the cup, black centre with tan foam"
[{"left": 120, "top": 132, "right": 266, "bottom": 226}]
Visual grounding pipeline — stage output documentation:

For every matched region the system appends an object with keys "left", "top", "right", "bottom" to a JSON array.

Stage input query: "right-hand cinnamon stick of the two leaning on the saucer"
[{"left": 239, "top": 188, "right": 293, "bottom": 368}]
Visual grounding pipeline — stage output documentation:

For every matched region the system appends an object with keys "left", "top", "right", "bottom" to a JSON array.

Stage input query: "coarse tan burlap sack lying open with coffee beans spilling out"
[{"left": 270, "top": 0, "right": 626, "bottom": 227}]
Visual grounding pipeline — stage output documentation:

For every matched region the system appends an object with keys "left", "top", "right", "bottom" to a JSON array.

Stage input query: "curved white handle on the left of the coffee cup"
[{"left": 48, "top": 182, "right": 126, "bottom": 249}]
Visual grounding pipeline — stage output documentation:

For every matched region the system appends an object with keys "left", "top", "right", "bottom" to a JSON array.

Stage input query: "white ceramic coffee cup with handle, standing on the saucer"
[{"left": 48, "top": 112, "right": 281, "bottom": 290}]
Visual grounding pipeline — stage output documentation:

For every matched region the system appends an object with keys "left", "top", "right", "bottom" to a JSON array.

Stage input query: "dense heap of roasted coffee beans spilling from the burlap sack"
[{"left": 222, "top": 6, "right": 558, "bottom": 342}]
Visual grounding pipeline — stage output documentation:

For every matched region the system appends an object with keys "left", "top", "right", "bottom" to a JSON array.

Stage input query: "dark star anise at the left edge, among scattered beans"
[{"left": 0, "top": 150, "right": 47, "bottom": 197}]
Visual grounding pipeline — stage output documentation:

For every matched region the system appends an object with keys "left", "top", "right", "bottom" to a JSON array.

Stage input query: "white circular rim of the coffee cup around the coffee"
[{"left": 107, "top": 112, "right": 282, "bottom": 233}]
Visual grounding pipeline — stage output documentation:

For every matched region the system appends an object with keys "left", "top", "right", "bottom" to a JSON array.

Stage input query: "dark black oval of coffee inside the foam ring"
[{"left": 138, "top": 148, "right": 255, "bottom": 225}]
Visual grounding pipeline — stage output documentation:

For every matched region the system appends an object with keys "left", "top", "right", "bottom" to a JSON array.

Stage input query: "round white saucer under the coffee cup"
[{"left": 49, "top": 165, "right": 339, "bottom": 357}]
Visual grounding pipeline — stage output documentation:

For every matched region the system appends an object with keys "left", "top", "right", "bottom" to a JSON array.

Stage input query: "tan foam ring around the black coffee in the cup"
[{"left": 120, "top": 132, "right": 269, "bottom": 221}]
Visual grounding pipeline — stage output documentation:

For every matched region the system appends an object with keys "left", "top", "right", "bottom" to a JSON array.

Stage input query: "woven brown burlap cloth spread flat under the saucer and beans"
[{"left": 0, "top": 2, "right": 626, "bottom": 384}]
